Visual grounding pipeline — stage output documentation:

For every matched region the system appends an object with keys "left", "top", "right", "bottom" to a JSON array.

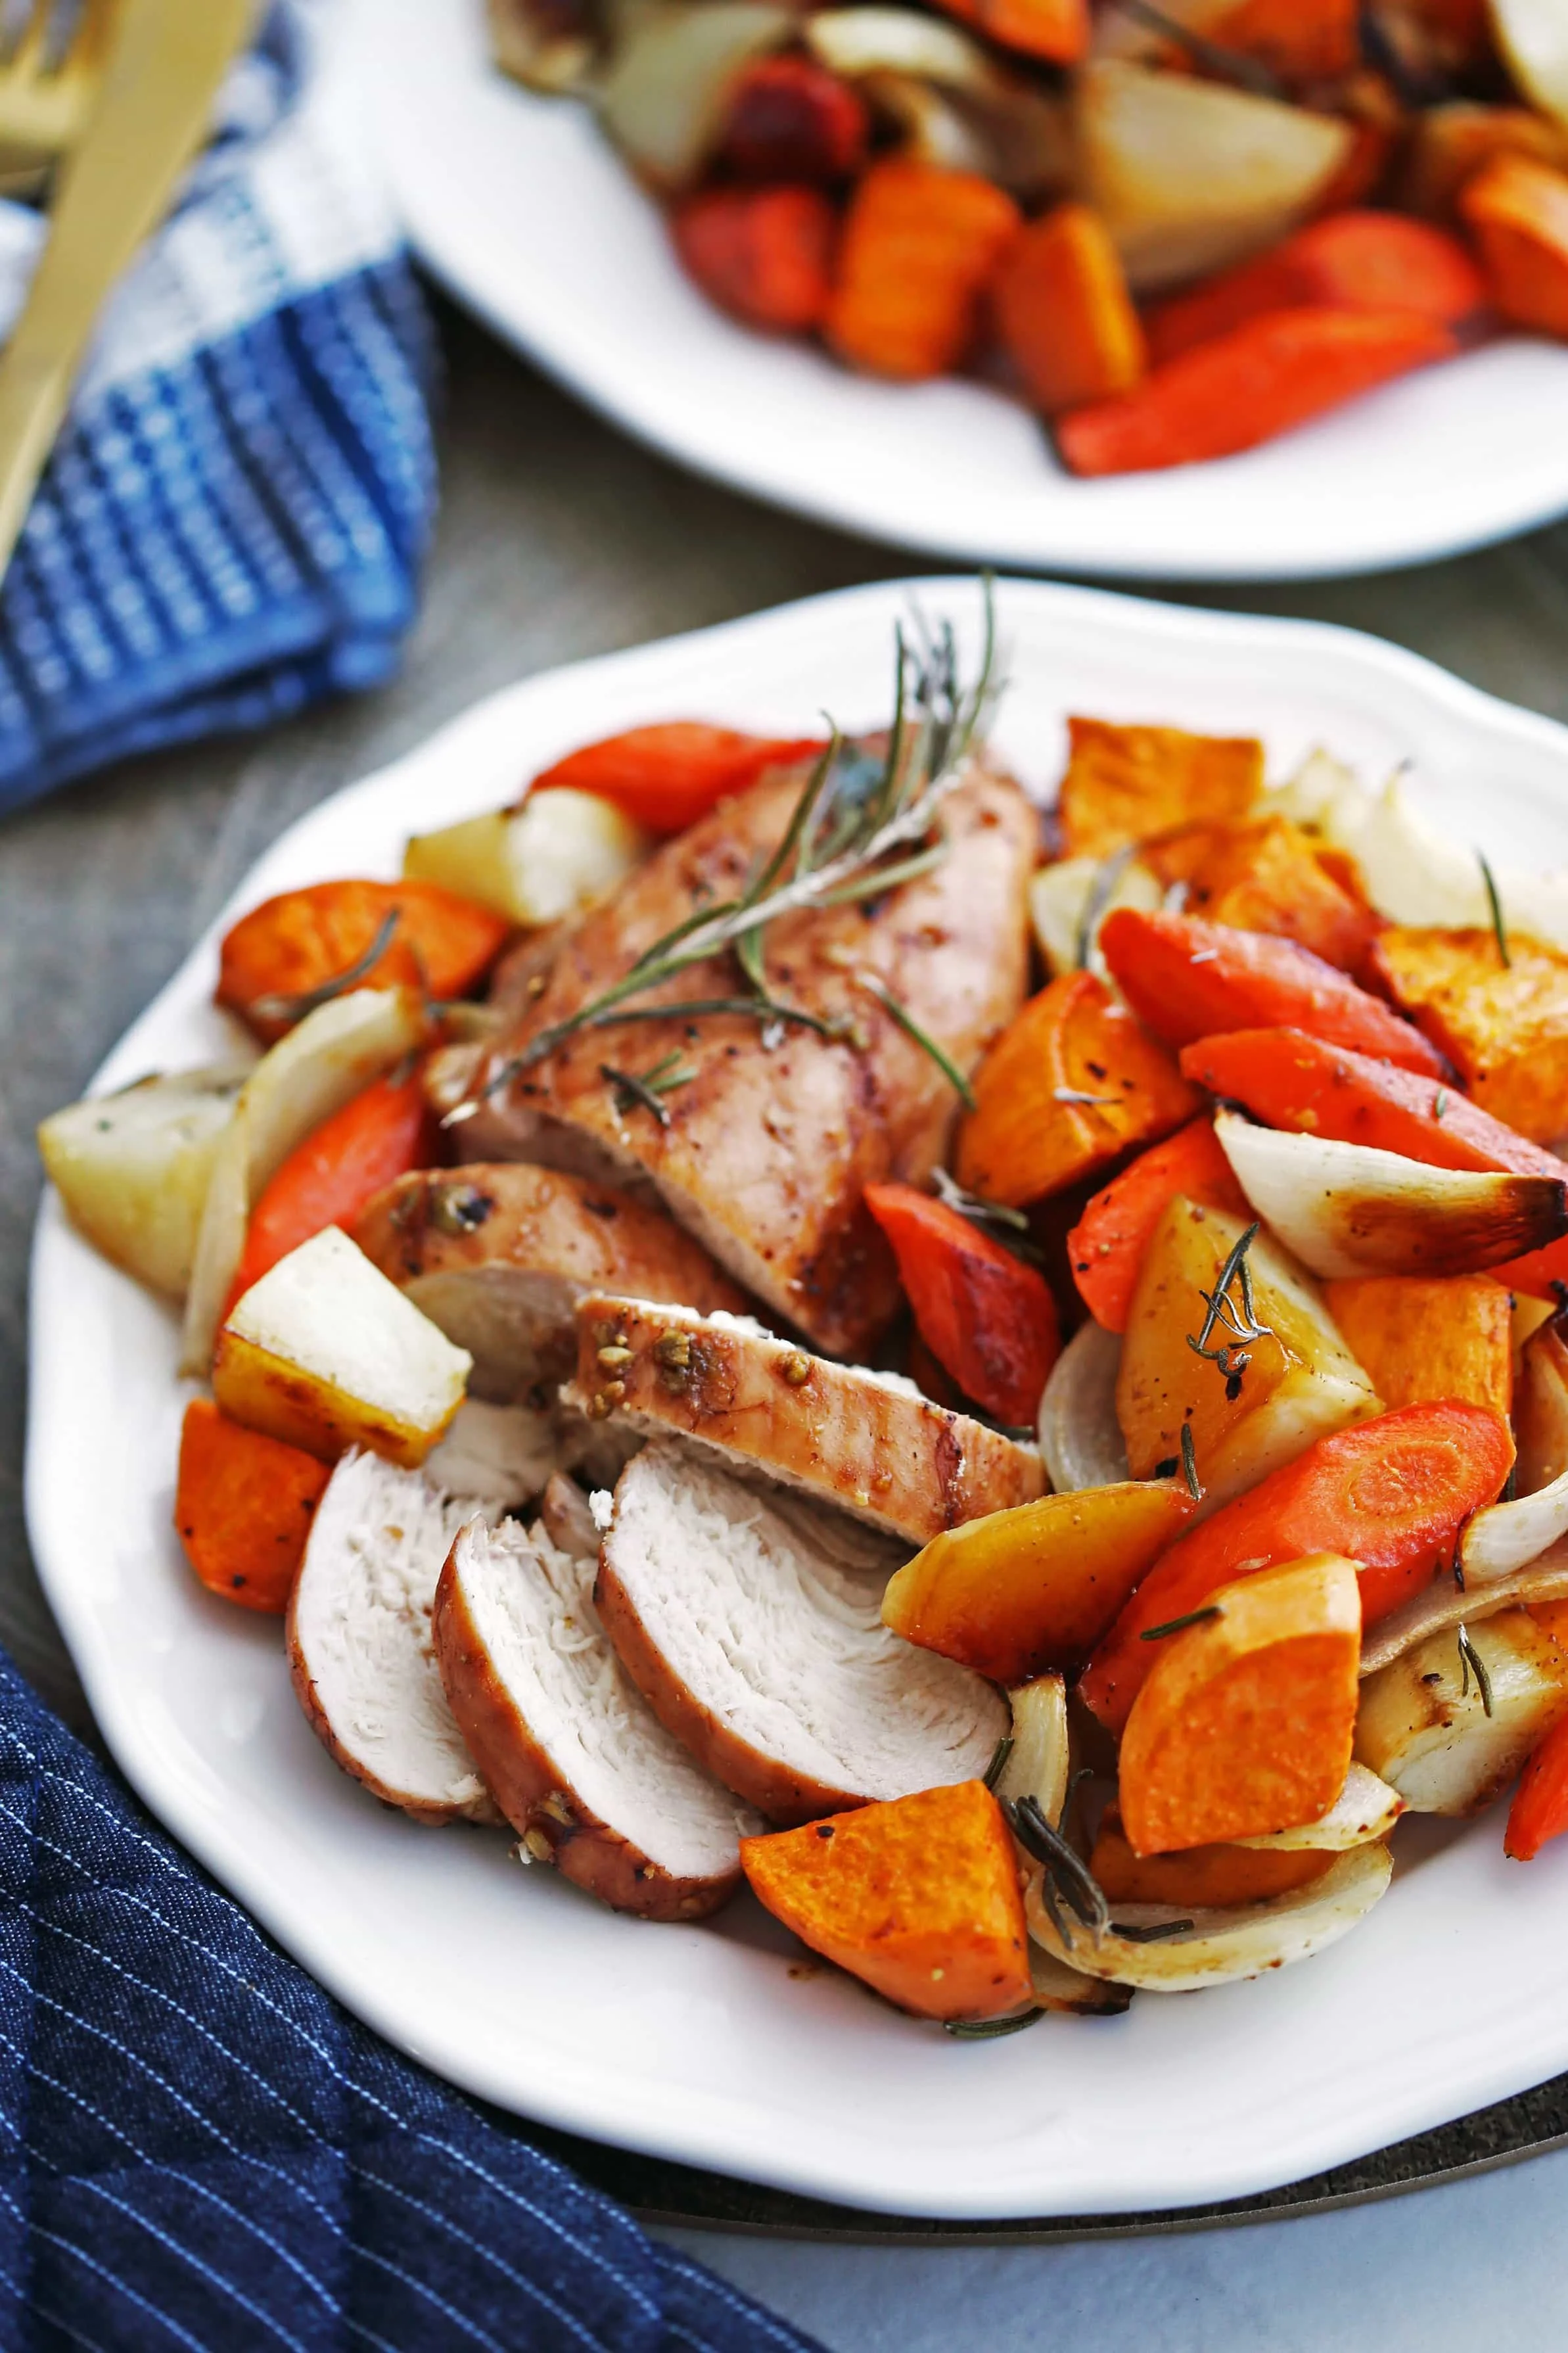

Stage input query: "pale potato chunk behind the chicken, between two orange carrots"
[{"left": 403, "top": 786, "right": 647, "bottom": 929}]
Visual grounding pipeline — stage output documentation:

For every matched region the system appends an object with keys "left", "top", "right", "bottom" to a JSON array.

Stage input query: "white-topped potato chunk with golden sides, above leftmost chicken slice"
[{"left": 212, "top": 1226, "right": 473, "bottom": 1471}]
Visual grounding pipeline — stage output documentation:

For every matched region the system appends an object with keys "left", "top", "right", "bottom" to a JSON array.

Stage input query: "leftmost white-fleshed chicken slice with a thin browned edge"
[{"left": 285, "top": 1454, "right": 501, "bottom": 1824}]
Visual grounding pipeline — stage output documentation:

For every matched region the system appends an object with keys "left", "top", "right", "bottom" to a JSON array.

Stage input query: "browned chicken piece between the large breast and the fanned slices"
[{"left": 351, "top": 1163, "right": 744, "bottom": 1403}]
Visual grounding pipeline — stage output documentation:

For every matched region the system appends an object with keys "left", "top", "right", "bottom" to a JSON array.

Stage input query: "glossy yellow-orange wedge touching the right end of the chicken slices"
[{"left": 883, "top": 1480, "right": 1193, "bottom": 1683}]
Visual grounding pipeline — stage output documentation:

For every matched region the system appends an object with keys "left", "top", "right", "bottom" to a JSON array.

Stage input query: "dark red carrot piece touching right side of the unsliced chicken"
[{"left": 866, "top": 1184, "right": 1062, "bottom": 1428}]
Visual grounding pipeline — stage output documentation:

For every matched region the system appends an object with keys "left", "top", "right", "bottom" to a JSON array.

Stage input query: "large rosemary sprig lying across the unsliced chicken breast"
[{"left": 485, "top": 579, "right": 996, "bottom": 1101}]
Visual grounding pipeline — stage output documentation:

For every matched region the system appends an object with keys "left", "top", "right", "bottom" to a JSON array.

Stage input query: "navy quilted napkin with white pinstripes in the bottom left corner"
[{"left": 0, "top": 1654, "right": 829, "bottom": 2353}]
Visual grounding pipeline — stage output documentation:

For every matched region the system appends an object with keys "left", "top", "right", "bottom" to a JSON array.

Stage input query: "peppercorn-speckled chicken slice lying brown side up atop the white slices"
[{"left": 563, "top": 1292, "right": 1046, "bottom": 1546}]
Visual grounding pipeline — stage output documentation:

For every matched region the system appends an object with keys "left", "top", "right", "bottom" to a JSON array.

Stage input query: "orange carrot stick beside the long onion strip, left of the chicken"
[{"left": 229, "top": 1075, "right": 438, "bottom": 1306}]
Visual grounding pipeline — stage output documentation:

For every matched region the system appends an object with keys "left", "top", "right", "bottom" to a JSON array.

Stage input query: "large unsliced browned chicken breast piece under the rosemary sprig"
[{"left": 459, "top": 748, "right": 1038, "bottom": 1355}]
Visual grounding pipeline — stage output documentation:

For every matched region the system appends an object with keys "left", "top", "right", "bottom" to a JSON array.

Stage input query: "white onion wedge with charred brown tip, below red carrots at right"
[{"left": 1215, "top": 1111, "right": 1568, "bottom": 1275}]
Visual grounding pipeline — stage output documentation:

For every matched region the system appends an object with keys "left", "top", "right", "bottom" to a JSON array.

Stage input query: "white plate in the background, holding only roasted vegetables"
[{"left": 358, "top": 0, "right": 1568, "bottom": 579}]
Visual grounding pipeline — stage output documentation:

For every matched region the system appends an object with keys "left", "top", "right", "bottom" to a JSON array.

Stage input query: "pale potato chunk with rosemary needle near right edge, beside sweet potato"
[{"left": 1356, "top": 1610, "right": 1568, "bottom": 1814}]
